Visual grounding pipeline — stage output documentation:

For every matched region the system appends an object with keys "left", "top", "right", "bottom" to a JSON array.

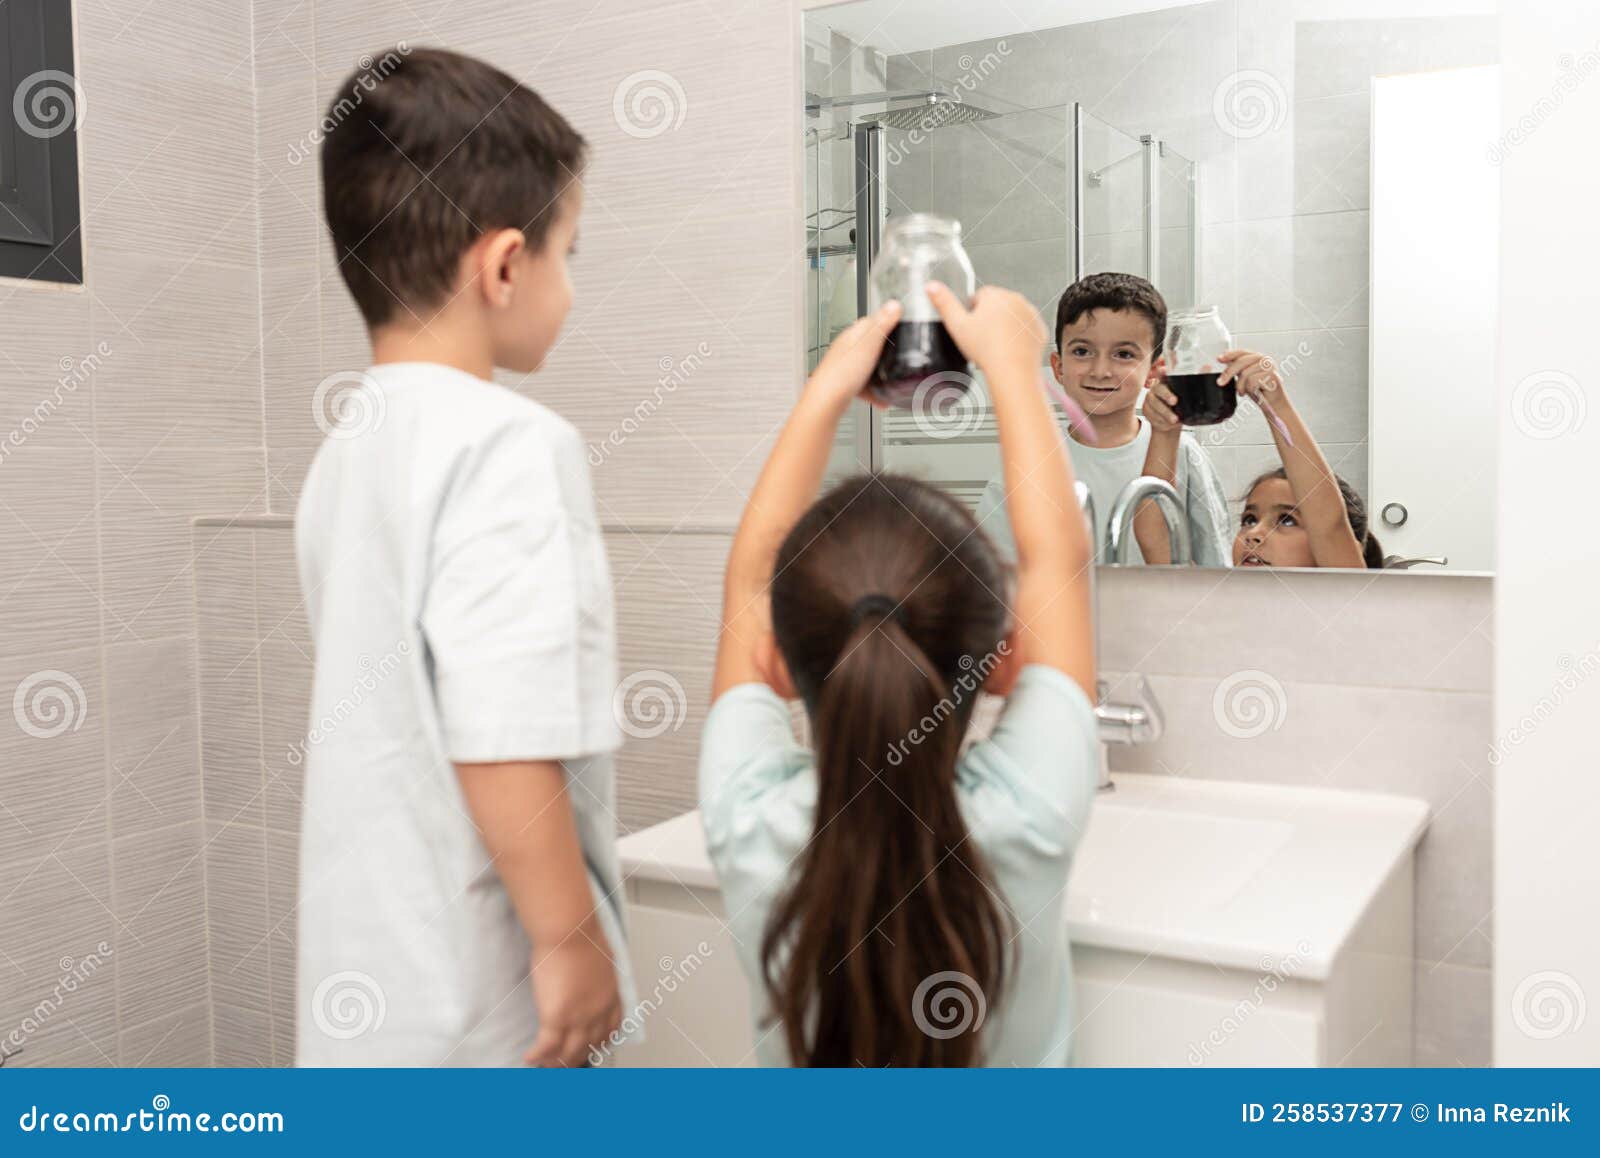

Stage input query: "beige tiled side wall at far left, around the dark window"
[{"left": 0, "top": 0, "right": 267, "bottom": 1065}]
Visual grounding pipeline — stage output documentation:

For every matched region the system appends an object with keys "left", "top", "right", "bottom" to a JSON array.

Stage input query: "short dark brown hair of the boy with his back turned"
[{"left": 322, "top": 45, "right": 586, "bottom": 326}]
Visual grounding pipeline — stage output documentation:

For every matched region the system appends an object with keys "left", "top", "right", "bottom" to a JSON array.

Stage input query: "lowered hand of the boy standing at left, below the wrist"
[{"left": 523, "top": 926, "right": 622, "bottom": 1065}]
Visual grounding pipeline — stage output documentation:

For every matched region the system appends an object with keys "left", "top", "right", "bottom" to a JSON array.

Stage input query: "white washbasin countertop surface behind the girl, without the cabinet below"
[{"left": 619, "top": 773, "right": 1427, "bottom": 980}]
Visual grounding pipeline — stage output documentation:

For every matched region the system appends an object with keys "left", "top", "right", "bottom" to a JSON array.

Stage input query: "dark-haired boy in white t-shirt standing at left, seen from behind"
[{"left": 294, "top": 50, "right": 632, "bottom": 1065}]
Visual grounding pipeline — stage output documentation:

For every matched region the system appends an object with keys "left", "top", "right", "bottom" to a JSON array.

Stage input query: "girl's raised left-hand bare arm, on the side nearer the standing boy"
[{"left": 712, "top": 302, "right": 901, "bottom": 701}]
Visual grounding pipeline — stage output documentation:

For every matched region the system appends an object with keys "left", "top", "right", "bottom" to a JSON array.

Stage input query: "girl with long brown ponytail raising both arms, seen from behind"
[{"left": 699, "top": 285, "right": 1098, "bottom": 1065}]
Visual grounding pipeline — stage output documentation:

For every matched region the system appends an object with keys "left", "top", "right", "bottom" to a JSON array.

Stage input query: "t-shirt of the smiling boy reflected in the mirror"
[{"left": 978, "top": 417, "right": 1234, "bottom": 566}]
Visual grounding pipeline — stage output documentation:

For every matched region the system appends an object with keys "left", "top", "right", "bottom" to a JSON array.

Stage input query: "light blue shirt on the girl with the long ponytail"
[{"left": 699, "top": 664, "right": 1099, "bottom": 1065}]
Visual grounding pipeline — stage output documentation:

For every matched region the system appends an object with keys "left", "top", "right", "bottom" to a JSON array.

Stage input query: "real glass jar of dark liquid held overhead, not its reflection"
[{"left": 867, "top": 213, "right": 978, "bottom": 406}]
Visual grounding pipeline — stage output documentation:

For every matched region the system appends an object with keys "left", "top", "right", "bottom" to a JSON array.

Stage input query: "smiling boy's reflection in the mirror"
[{"left": 978, "top": 274, "right": 1232, "bottom": 566}]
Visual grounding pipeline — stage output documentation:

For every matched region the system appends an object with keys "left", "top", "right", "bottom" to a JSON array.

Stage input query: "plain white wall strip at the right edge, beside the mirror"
[{"left": 1494, "top": 0, "right": 1600, "bottom": 1065}]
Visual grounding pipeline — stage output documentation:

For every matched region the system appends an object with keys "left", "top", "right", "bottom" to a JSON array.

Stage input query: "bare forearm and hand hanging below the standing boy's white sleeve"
[{"left": 456, "top": 760, "right": 622, "bottom": 1065}]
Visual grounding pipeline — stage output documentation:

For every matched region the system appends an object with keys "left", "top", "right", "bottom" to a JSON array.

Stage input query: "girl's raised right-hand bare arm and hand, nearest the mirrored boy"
[{"left": 928, "top": 283, "right": 1096, "bottom": 702}]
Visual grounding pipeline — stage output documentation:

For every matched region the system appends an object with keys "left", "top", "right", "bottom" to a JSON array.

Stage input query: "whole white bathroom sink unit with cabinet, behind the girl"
[{"left": 619, "top": 774, "right": 1427, "bottom": 1065}]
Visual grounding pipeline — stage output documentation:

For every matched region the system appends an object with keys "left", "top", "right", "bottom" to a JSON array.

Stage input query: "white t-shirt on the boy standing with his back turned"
[{"left": 294, "top": 363, "right": 634, "bottom": 1065}]
